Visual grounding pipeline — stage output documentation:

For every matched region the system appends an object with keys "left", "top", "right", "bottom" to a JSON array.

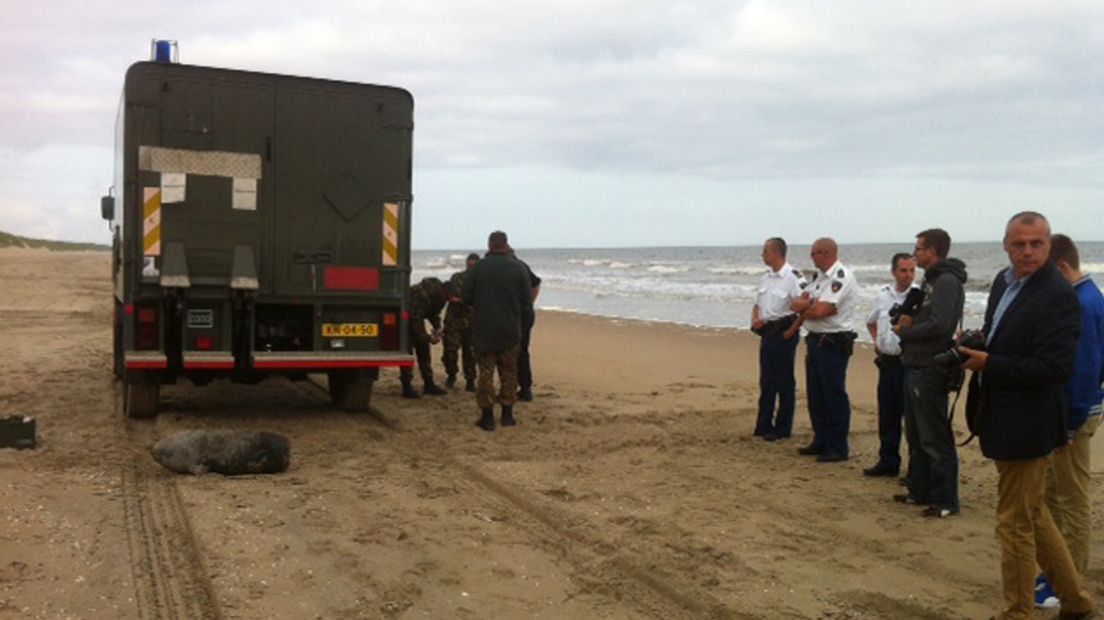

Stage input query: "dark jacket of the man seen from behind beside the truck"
[{"left": 463, "top": 248, "right": 533, "bottom": 352}]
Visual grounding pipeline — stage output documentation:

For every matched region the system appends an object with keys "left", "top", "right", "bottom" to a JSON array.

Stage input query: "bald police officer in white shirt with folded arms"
[{"left": 790, "top": 237, "right": 859, "bottom": 462}]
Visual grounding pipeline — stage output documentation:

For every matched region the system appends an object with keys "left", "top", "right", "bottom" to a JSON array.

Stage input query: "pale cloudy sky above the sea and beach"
[{"left": 0, "top": 0, "right": 1104, "bottom": 249}]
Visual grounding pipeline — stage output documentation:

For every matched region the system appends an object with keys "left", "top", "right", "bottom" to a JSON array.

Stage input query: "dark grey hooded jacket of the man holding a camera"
[{"left": 898, "top": 258, "right": 966, "bottom": 366}]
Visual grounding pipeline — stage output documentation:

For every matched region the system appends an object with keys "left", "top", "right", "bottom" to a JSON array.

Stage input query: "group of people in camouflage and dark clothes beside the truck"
[{"left": 400, "top": 231, "right": 541, "bottom": 430}]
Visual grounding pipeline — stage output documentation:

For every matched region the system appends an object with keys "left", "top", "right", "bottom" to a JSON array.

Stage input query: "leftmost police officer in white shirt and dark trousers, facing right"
[{"left": 752, "top": 237, "right": 806, "bottom": 441}]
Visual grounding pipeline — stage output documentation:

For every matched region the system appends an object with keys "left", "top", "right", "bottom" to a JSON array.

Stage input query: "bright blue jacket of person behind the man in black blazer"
[{"left": 1065, "top": 276, "right": 1104, "bottom": 434}]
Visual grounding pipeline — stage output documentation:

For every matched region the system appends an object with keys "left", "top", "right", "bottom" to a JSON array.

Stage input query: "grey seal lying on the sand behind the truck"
[{"left": 151, "top": 429, "right": 291, "bottom": 475}]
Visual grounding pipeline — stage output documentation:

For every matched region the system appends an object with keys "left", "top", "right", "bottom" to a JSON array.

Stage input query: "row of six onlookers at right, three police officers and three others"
[{"left": 752, "top": 212, "right": 1104, "bottom": 620}]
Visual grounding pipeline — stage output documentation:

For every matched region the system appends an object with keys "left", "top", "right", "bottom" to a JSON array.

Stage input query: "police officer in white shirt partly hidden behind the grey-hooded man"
[{"left": 862, "top": 253, "right": 920, "bottom": 477}]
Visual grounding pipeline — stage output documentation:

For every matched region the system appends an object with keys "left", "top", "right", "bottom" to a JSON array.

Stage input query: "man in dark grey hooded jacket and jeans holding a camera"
[{"left": 894, "top": 228, "right": 966, "bottom": 517}]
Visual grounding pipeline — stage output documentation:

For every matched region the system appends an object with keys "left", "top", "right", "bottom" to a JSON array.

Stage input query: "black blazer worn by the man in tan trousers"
[{"left": 972, "top": 263, "right": 1081, "bottom": 460}]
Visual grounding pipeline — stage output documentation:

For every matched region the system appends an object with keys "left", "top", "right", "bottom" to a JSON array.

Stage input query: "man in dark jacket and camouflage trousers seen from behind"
[{"left": 463, "top": 231, "right": 533, "bottom": 430}]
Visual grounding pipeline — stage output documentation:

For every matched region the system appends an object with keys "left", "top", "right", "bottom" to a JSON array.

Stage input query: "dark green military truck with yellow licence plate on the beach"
[{"left": 100, "top": 48, "right": 414, "bottom": 418}]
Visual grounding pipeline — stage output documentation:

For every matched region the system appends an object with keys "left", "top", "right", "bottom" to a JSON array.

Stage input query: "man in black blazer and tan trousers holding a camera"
[{"left": 958, "top": 212, "right": 1095, "bottom": 620}]
